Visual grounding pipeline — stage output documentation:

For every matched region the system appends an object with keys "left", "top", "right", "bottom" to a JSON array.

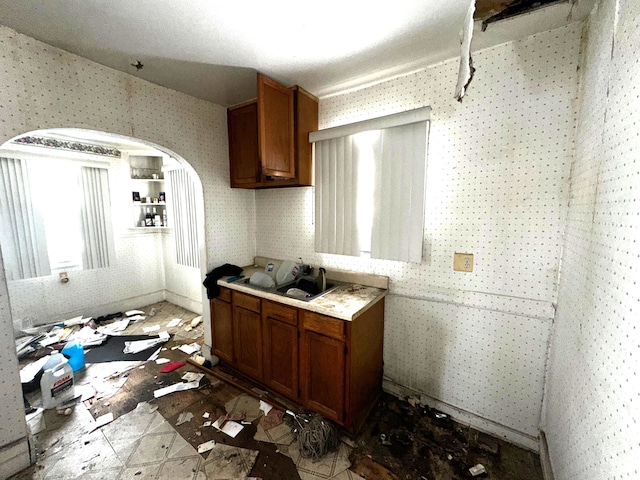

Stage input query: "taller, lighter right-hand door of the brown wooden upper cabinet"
[{"left": 258, "top": 74, "right": 296, "bottom": 178}]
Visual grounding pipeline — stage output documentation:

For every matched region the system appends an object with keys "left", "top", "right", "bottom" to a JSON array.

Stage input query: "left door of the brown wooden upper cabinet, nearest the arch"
[{"left": 227, "top": 101, "right": 260, "bottom": 188}]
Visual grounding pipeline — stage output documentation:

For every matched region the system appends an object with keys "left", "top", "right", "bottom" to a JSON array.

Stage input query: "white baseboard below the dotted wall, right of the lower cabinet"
[{"left": 382, "top": 378, "right": 540, "bottom": 453}]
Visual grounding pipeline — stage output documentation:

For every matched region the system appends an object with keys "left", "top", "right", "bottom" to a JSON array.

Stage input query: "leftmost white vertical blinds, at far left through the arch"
[{"left": 0, "top": 157, "right": 51, "bottom": 280}]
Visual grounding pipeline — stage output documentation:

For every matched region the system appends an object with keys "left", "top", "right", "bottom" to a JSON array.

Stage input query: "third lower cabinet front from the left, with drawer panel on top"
[{"left": 262, "top": 301, "right": 298, "bottom": 401}]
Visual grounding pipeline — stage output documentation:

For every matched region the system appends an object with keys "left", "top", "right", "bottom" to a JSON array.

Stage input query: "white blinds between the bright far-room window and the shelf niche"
[{"left": 80, "top": 167, "right": 115, "bottom": 270}]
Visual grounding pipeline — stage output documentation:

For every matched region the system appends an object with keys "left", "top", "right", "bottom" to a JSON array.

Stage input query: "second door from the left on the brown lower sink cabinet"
[{"left": 233, "top": 305, "right": 262, "bottom": 381}]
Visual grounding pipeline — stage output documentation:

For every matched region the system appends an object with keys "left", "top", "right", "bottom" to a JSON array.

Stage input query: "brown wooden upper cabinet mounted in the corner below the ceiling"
[{"left": 227, "top": 74, "right": 318, "bottom": 188}]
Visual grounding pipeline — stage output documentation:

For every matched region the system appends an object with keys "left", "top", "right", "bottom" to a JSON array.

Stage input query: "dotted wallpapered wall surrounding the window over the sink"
[{"left": 256, "top": 23, "right": 581, "bottom": 445}]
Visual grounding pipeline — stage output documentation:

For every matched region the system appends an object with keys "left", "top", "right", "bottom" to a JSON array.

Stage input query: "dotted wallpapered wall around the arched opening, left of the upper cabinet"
[{"left": 0, "top": 22, "right": 255, "bottom": 472}]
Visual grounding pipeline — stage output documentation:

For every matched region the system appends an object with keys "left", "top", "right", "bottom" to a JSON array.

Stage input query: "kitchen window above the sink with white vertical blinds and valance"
[{"left": 309, "top": 107, "right": 430, "bottom": 263}]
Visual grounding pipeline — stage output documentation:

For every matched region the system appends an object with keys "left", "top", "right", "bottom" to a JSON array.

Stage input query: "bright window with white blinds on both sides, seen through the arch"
[{"left": 0, "top": 158, "right": 114, "bottom": 280}]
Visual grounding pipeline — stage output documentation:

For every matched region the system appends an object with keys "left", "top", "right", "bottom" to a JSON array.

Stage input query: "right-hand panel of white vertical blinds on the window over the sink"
[{"left": 371, "top": 122, "right": 427, "bottom": 263}]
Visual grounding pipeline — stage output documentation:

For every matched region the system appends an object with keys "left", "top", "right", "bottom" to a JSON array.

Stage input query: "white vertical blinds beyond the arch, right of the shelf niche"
[{"left": 167, "top": 169, "right": 200, "bottom": 268}]
